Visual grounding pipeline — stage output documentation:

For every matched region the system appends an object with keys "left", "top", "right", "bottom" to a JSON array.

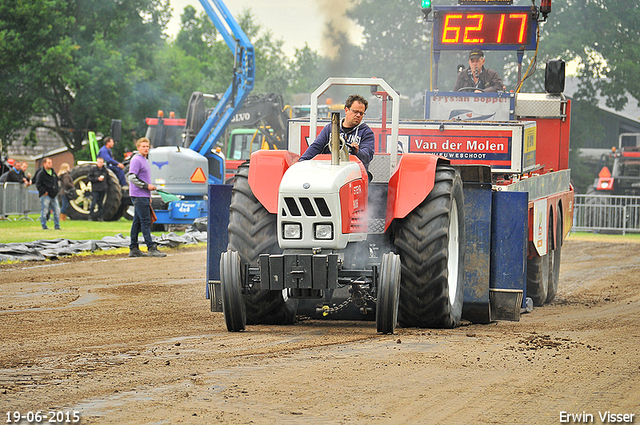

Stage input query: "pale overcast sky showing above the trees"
[{"left": 169, "top": 0, "right": 358, "bottom": 57}]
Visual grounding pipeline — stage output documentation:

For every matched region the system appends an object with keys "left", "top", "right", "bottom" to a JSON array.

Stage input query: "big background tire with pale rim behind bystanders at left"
[{"left": 67, "top": 164, "right": 122, "bottom": 220}]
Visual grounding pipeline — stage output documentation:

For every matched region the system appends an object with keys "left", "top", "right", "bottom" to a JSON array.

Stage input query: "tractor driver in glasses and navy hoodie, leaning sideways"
[{"left": 299, "top": 94, "right": 375, "bottom": 170}]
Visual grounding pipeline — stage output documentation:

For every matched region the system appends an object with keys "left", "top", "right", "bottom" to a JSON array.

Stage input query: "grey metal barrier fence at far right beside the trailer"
[{"left": 572, "top": 195, "right": 640, "bottom": 235}]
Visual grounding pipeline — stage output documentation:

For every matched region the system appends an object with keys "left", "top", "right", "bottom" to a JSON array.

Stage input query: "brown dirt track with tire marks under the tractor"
[{"left": 0, "top": 240, "right": 640, "bottom": 425}]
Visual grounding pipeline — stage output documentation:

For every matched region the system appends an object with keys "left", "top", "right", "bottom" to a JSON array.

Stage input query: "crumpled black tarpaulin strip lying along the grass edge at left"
[{"left": 0, "top": 230, "right": 207, "bottom": 261}]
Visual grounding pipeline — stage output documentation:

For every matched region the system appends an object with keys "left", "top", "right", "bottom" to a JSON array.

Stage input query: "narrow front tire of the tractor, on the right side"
[{"left": 376, "top": 252, "right": 402, "bottom": 334}]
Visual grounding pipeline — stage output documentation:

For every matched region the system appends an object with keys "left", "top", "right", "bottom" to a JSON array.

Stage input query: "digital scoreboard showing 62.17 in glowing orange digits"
[{"left": 433, "top": 5, "right": 538, "bottom": 50}]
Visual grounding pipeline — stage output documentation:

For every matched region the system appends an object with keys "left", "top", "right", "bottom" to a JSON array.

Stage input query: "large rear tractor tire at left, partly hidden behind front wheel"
[{"left": 228, "top": 163, "right": 298, "bottom": 325}]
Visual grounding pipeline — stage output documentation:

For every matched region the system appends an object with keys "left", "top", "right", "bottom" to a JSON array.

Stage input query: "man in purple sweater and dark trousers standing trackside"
[{"left": 127, "top": 137, "right": 167, "bottom": 257}]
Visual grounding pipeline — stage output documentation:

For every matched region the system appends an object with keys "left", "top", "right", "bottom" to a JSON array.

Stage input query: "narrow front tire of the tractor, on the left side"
[{"left": 220, "top": 251, "right": 247, "bottom": 332}]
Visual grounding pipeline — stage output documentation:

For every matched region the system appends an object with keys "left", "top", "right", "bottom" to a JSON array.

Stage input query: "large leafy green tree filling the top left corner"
[{"left": 0, "top": 0, "right": 169, "bottom": 152}]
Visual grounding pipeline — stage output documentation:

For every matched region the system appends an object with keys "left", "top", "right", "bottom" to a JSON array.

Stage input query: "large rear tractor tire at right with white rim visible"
[{"left": 394, "top": 165, "right": 465, "bottom": 328}]
